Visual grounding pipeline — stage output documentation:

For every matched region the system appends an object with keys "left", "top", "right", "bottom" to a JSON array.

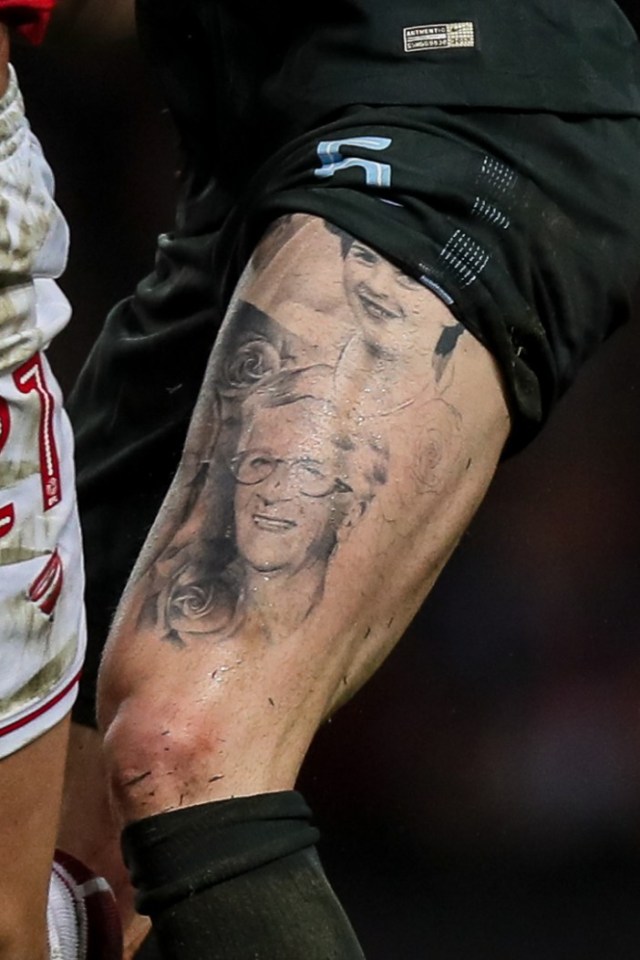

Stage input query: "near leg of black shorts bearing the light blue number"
[{"left": 215, "top": 106, "right": 640, "bottom": 452}]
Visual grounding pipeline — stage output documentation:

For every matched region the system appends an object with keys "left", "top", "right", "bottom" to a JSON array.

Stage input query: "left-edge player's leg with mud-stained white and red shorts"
[{"left": 0, "top": 31, "right": 119, "bottom": 960}]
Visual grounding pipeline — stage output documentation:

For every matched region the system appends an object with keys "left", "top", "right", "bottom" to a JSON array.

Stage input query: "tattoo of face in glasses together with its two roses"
[{"left": 147, "top": 304, "right": 388, "bottom": 645}]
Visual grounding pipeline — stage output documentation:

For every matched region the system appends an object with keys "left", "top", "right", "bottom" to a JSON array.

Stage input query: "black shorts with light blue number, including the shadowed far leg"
[{"left": 69, "top": 13, "right": 640, "bottom": 723}]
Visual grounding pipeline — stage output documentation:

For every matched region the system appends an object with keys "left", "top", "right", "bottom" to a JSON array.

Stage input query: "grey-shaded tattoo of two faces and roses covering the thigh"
[{"left": 140, "top": 217, "right": 463, "bottom": 646}]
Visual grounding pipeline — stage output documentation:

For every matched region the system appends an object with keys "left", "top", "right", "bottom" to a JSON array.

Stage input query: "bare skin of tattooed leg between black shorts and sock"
[{"left": 100, "top": 215, "right": 509, "bottom": 840}]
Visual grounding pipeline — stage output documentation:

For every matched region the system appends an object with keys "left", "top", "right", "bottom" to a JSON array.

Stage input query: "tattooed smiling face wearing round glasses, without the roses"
[{"left": 231, "top": 367, "right": 386, "bottom": 587}]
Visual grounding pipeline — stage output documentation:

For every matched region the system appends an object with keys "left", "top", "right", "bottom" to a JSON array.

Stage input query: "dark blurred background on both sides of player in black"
[{"left": 14, "top": 11, "right": 640, "bottom": 960}]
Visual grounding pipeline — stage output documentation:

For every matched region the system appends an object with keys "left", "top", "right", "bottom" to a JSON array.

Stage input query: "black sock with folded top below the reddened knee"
[{"left": 123, "top": 792, "right": 364, "bottom": 960}]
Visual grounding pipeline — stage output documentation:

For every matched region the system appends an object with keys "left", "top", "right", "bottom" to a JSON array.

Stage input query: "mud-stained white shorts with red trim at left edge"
[{"left": 0, "top": 65, "right": 85, "bottom": 759}]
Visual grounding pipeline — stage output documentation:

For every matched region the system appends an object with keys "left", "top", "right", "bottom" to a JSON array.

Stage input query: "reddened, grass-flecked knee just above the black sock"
[{"left": 97, "top": 660, "right": 310, "bottom": 823}]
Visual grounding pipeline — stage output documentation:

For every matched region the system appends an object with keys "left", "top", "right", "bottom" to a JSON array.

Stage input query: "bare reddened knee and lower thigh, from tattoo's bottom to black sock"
[{"left": 98, "top": 600, "right": 318, "bottom": 822}]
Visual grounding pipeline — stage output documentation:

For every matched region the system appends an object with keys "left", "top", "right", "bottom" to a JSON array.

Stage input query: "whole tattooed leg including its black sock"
[{"left": 101, "top": 216, "right": 509, "bottom": 960}]
